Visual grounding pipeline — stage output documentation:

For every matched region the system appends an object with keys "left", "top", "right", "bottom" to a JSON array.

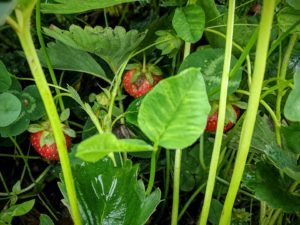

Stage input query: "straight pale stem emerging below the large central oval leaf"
[{"left": 171, "top": 149, "right": 182, "bottom": 225}]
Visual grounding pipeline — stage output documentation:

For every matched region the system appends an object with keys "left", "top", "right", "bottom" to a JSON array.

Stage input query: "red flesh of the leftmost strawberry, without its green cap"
[{"left": 30, "top": 131, "right": 71, "bottom": 160}]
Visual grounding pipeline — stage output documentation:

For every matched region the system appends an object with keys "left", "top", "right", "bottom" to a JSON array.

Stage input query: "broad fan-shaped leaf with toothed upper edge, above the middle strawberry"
[{"left": 44, "top": 25, "right": 146, "bottom": 72}]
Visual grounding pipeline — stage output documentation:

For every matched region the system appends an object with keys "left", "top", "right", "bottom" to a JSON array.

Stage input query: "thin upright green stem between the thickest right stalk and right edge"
[{"left": 275, "top": 33, "right": 298, "bottom": 146}]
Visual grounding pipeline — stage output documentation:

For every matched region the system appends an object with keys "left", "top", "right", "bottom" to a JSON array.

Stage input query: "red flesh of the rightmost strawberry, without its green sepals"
[{"left": 205, "top": 106, "right": 241, "bottom": 133}]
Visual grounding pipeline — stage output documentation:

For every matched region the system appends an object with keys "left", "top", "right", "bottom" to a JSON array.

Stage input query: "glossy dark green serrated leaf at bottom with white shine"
[{"left": 59, "top": 158, "right": 160, "bottom": 225}]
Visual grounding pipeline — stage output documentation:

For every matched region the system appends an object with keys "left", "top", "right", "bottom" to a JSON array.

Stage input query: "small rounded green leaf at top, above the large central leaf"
[{"left": 172, "top": 4, "right": 205, "bottom": 43}]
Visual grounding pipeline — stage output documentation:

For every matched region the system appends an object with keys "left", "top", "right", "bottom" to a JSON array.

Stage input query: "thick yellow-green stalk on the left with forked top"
[{"left": 7, "top": 8, "right": 81, "bottom": 225}]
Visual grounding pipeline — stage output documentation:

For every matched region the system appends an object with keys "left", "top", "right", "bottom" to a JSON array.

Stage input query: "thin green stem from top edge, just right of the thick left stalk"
[{"left": 35, "top": 0, "right": 65, "bottom": 111}]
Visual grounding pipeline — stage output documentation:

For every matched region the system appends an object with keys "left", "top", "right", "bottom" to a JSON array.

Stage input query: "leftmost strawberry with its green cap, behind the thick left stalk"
[{"left": 28, "top": 121, "right": 75, "bottom": 161}]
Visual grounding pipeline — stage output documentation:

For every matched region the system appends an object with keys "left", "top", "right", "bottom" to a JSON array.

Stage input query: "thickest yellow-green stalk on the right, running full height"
[{"left": 219, "top": 0, "right": 275, "bottom": 225}]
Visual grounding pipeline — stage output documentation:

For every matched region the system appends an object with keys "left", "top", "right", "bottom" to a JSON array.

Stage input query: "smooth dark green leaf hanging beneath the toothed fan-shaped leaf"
[{"left": 38, "top": 42, "right": 109, "bottom": 82}]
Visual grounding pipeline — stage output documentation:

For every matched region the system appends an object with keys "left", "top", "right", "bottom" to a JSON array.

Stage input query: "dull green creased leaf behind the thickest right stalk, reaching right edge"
[{"left": 230, "top": 116, "right": 300, "bottom": 181}]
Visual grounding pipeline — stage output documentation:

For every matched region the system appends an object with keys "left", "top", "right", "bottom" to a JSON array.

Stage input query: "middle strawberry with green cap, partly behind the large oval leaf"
[{"left": 123, "top": 63, "right": 162, "bottom": 98}]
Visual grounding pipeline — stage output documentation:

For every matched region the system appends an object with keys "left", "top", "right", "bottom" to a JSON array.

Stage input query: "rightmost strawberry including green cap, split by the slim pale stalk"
[{"left": 205, "top": 103, "right": 241, "bottom": 133}]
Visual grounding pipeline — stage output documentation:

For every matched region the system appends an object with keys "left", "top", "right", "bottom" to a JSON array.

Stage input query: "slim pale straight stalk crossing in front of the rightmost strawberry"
[{"left": 199, "top": 0, "right": 235, "bottom": 225}]
